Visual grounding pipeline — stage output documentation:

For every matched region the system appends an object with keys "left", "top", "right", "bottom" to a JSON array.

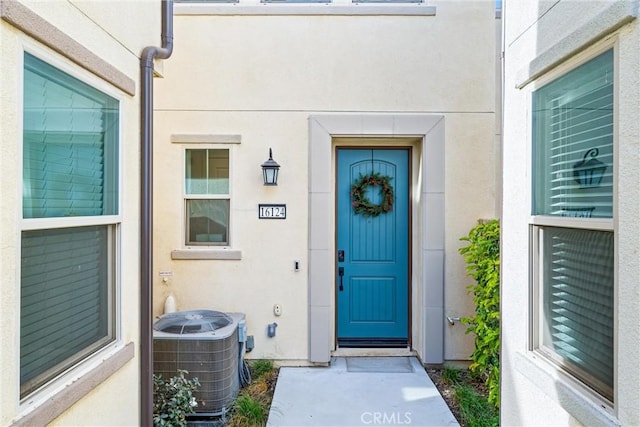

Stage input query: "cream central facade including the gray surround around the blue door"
[{"left": 154, "top": 1, "right": 500, "bottom": 363}]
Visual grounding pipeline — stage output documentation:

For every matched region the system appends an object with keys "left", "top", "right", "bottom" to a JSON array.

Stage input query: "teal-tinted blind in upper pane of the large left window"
[{"left": 23, "top": 54, "right": 118, "bottom": 218}]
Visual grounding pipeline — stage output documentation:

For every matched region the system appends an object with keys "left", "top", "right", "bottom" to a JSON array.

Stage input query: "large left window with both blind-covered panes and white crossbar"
[{"left": 20, "top": 53, "right": 119, "bottom": 397}]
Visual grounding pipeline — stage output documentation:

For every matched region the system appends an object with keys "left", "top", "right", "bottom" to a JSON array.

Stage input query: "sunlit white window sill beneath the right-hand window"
[{"left": 515, "top": 352, "right": 619, "bottom": 425}]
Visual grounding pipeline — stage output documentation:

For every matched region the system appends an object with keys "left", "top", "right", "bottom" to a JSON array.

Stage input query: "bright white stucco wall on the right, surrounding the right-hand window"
[{"left": 501, "top": 1, "right": 640, "bottom": 425}]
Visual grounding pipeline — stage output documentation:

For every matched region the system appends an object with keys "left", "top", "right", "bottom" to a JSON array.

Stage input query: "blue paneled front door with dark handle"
[{"left": 336, "top": 148, "right": 409, "bottom": 347}]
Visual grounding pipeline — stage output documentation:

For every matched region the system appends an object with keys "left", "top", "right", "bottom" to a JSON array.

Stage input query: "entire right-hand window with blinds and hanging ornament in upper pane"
[{"left": 531, "top": 50, "right": 615, "bottom": 401}]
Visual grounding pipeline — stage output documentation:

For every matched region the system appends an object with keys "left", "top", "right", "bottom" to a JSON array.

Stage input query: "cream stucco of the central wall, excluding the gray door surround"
[{"left": 154, "top": 1, "right": 496, "bottom": 361}]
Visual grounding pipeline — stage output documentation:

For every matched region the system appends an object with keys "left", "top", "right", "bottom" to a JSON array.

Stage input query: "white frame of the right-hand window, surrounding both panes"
[{"left": 528, "top": 44, "right": 619, "bottom": 409}]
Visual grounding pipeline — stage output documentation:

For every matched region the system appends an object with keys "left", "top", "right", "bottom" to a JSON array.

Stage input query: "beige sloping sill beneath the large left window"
[{"left": 12, "top": 342, "right": 135, "bottom": 427}]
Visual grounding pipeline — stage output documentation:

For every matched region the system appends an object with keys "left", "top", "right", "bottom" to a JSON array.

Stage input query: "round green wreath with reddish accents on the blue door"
[{"left": 351, "top": 172, "right": 393, "bottom": 217}]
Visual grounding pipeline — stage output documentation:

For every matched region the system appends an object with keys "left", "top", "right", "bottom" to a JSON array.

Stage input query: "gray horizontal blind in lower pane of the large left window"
[{"left": 20, "top": 226, "right": 111, "bottom": 395}]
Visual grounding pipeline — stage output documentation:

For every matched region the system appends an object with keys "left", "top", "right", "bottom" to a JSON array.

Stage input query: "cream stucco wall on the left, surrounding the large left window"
[{"left": 0, "top": 1, "right": 160, "bottom": 425}]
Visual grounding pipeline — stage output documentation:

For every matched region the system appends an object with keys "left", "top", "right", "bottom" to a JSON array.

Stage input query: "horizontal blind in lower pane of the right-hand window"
[{"left": 543, "top": 227, "right": 614, "bottom": 398}]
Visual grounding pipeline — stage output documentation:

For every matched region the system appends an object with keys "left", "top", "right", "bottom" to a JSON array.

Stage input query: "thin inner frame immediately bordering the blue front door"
[{"left": 332, "top": 145, "right": 416, "bottom": 349}]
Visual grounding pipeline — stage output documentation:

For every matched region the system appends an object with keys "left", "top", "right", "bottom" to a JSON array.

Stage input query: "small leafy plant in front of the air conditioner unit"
[{"left": 153, "top": 370, "right": 200, "bottom": 427}]
